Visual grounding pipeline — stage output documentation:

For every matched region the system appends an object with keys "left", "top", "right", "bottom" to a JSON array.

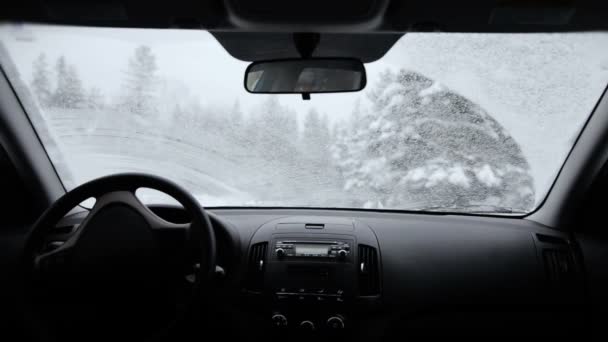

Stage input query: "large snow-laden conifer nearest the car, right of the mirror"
[{"left": 333, "top": 70, "right": 534, "bottom": 210}]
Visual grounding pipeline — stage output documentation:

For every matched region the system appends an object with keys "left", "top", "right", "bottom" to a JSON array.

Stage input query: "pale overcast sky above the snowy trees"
[{"left": 0, "top": 25, "right": 608, "bottom": 200}]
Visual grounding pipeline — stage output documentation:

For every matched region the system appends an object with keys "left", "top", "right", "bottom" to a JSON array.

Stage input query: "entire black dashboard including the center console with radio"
[{"left": 52, "top": 206, "right": 586, "bottom": 340}]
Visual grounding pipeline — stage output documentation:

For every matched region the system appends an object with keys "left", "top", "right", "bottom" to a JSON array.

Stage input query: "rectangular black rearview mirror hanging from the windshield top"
[{"left": 245, "top": 58, "right": 367, "bottom": 96}]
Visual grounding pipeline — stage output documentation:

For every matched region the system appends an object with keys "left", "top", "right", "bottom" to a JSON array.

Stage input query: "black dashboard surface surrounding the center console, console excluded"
[{"left": 0, "top": 206, "right": 585, "bottom": 338}]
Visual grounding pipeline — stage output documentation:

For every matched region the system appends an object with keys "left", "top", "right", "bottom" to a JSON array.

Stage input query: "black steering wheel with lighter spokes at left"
[{"left": 24, "top": 173, "right": 216, "bottom": 337}]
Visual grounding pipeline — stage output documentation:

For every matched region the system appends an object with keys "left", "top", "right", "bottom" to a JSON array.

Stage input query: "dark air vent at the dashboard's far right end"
[{"left": 543, "top": 249, "right": 576, "bottom": 288}]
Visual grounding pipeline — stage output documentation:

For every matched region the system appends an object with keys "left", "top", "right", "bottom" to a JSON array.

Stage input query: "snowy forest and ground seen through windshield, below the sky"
[{"left": 29, "top": 45, "right": 534, "bottom": 212}]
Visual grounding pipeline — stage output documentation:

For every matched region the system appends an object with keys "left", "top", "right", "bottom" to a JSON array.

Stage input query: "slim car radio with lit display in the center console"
[{"left": 274, "top": 240, "right": 350, "bottom": 260}]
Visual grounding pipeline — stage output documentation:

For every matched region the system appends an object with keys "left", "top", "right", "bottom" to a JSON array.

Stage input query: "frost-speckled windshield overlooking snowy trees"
[{"left": 0, "top": 25, "right": 608, "bottom": 213}]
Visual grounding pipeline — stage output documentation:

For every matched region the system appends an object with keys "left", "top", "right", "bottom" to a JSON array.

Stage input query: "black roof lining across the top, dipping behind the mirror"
[{"left": 0, "top": 0, "right": 608, "bottom": 62}]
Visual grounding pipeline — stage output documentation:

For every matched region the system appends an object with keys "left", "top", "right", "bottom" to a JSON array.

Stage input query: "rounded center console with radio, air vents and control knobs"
[{"left": 246, "top": 216, "right": 381, "bottom": 336}]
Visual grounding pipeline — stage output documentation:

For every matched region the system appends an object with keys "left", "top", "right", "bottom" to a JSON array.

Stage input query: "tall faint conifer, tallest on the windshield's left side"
[{"left": 122, "top": 45, "right": 158, "bottom": 115}]
